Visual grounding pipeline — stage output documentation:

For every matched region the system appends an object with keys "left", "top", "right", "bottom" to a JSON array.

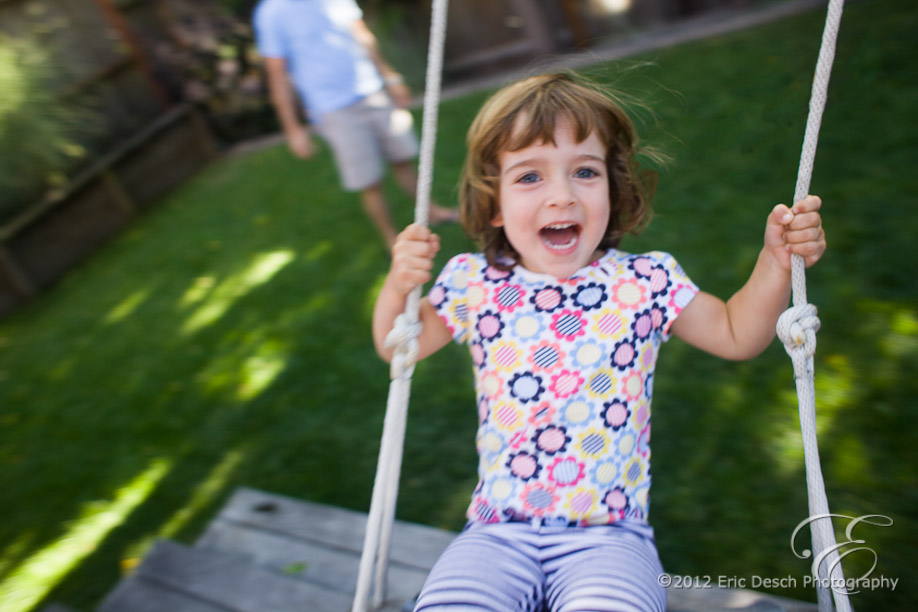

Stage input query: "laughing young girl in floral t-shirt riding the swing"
[{"left": 373, "top": 74, "right": 826, "bottom": 612}]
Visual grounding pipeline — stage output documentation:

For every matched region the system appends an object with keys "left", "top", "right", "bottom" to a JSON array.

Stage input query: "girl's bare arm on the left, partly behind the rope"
[{"left": 373, "top": 224, "right": 452, "bottom": 362}]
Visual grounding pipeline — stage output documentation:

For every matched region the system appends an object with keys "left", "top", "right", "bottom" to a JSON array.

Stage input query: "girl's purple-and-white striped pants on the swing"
[{"left": 415, "top": 520, "right": 666, "bottom": 612}]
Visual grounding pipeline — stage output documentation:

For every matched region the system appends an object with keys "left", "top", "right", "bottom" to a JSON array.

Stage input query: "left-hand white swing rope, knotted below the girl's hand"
[{"left": 352, "top": 0, "right": 448, "bottom": 612}]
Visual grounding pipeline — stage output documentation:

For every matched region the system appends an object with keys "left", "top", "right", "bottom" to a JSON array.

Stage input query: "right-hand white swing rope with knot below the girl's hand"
[{"left": 777, "top": 0, "right": 851, "bottom": 612}]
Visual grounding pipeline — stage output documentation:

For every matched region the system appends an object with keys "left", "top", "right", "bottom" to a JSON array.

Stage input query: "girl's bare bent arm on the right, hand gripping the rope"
[{"left": 672, "top": 196, "right": 826, "bottom": 360}]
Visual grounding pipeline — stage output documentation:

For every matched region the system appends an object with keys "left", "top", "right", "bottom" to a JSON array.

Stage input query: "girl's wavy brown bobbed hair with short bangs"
[{"left": 459, "top": 72, "right": 657, "bottom": 268}]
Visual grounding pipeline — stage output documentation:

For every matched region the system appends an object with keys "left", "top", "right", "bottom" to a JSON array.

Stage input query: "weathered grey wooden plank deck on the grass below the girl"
[{"left": 99, "top": 488, "right": 817, "bottom": 612}]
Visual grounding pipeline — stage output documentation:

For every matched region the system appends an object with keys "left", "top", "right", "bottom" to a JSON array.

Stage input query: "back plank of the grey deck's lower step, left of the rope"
[{"left": 137, "top": 540, "right": 352, "bottom": 612}]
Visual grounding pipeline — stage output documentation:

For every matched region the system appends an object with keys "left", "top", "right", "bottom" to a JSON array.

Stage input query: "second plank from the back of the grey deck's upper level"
[{"left": 195, "top": 519, "right": 429, "bottom": 603}]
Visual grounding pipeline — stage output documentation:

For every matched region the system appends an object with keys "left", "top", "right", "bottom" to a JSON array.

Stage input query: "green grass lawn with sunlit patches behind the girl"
[{"left": 0, "top": 0, "right": 918, "bottom": 612}]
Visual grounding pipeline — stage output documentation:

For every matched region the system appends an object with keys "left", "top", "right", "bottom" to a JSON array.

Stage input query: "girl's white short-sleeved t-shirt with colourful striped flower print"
[{"left": 428, "top": 249, "right": 698, "bottom": 525}]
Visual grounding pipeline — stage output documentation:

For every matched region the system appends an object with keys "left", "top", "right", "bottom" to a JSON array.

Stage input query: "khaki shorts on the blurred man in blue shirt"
[{"left": 315, "top": 91, "right": 418, "bottom": 191}]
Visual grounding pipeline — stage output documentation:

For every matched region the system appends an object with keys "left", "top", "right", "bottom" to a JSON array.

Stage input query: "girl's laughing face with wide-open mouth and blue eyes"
[{"left": 491, "top": 119, "right": 610, "bottom": 278}]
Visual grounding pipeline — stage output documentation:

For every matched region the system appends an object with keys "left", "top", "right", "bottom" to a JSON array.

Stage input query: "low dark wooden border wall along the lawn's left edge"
[{"left": 0, "top": 104, "right": 217, "bottom": 315}]
